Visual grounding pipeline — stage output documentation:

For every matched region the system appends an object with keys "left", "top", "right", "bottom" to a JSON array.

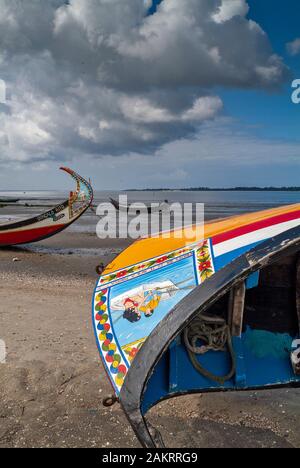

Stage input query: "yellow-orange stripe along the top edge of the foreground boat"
[{"left": 103, "top": 204, "right": 300, "bottom": 275}]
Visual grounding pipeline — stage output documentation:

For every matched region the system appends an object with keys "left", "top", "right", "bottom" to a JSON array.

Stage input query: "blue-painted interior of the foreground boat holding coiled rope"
[{"left": 142, "top": 254, "right": 300, "bottom": 414}]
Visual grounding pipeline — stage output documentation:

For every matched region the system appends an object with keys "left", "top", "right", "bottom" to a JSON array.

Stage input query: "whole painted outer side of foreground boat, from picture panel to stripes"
[{"left": 93, "top": 205, "right": 300, "bottom": 394}]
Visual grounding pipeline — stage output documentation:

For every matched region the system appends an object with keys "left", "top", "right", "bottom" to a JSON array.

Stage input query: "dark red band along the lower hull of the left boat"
[{"left": 0, "top": 224, "right": 68, "bottom": 246}]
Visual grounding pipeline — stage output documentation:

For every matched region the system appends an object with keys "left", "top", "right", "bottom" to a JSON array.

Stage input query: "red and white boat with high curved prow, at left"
[{"left": 0, "top": 167, "right": 93, "bottom": 247}]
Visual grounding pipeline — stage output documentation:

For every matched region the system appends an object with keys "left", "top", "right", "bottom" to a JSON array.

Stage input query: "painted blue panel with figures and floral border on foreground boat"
[{"left": 93, "top": 240, "right": 214, "bottom": 393}]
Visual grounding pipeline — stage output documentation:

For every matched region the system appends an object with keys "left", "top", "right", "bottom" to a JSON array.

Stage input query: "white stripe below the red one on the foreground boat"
[{"left": 213, "top": 219, "right": 300, "bottom": 257}]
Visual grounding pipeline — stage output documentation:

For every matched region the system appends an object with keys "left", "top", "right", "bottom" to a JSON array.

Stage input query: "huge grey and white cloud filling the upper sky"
[{"left": 0, "top": 0, "right": 287, "bottom": 164}]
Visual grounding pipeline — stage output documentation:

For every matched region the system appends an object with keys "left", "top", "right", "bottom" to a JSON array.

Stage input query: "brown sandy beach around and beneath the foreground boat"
[{"left": 0, "top": 232, "right": 300, "bottom": 448}]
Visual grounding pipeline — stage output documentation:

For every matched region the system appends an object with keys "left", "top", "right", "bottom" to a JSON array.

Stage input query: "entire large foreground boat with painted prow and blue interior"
[{"left": 93, "top": 204, "right": 300, "bottom": 448}]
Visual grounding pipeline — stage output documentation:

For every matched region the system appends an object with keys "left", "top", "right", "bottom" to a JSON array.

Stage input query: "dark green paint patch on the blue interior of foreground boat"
[{"left": 244, "top": 328, "right": 293, "bottom": 359}]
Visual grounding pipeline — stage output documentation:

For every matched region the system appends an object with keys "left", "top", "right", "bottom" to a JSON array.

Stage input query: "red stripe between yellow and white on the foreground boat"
[{"left": 212, "top": 210, "right": 300, "bottom": 245}]
